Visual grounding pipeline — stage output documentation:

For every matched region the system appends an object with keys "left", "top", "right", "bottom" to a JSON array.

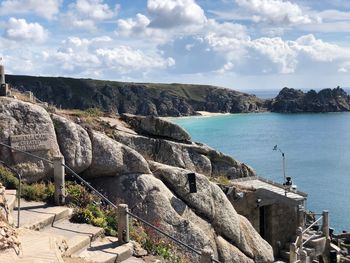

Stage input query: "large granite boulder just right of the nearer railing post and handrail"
[{"left": 92, "top": 174, "right": 217, "bottom": 262}]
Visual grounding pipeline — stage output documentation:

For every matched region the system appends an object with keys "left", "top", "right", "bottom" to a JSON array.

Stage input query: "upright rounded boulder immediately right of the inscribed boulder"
[{"left": 51, "top": 114, "right": 92, "bottom": 173}]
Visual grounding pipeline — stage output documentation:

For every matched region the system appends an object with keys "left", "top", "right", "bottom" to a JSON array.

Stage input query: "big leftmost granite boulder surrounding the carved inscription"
[{"left": 0, "top": 97, "right": 61, "bottom": 182}]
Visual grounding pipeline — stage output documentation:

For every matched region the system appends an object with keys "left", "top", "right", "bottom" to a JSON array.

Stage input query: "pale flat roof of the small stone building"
[{"left": 231, "top": 176, "right": 307, "bottom": 201}]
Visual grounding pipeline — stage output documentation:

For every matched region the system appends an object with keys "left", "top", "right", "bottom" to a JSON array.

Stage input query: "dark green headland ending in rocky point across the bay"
[{"left": 6, "top": 75, "right": 350, "bottom": 117}]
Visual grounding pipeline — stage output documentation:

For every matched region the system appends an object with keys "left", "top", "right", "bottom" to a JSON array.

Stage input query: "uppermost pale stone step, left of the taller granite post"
[{"left": 13, "top": 199, "right": 73, "bottom": 230}]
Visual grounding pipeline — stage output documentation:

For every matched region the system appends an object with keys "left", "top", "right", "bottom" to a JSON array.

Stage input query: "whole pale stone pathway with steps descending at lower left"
[{"left": 0, "top": 193, "right": 141, "bottom": 263}]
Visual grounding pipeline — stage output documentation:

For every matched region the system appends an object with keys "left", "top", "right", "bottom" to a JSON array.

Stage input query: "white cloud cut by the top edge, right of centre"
[{"left": 236, "top": 0, "right": 319, "bottom": 25}]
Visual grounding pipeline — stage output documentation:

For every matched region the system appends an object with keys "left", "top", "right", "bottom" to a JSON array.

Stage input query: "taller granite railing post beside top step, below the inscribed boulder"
[{"left": 53, "top": 156, "right": 66, "bottom": 205}]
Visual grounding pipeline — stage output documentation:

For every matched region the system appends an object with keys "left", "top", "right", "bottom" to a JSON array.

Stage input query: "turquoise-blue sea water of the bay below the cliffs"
[{"left": 172, "top": 113, "right": 350, "bottom": 232}]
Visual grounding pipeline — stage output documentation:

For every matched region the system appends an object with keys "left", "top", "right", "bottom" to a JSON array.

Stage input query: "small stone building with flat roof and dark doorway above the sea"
[{"left": 224, "top": 176, "right": 307, "bottom": 256}]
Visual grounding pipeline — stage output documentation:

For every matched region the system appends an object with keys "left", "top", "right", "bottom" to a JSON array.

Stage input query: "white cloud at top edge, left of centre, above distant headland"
[{"left": 63, "top": 0, "right": 119, "bottom": 30}]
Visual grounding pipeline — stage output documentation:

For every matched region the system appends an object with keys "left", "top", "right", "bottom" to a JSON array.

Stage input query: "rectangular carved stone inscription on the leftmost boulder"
[{"left": 10, "top": 133, "right": 51, "bottom": 151}]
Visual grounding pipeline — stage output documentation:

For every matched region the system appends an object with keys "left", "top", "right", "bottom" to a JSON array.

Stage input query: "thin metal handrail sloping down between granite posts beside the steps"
[{"left": 0, "top": 142, "right": 221, "bottom": 263}]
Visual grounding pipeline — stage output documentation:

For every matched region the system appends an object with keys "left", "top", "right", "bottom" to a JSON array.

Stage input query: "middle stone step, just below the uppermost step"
[{"left": 41, "top": 220, "right": 104, "bottom": 256}]
